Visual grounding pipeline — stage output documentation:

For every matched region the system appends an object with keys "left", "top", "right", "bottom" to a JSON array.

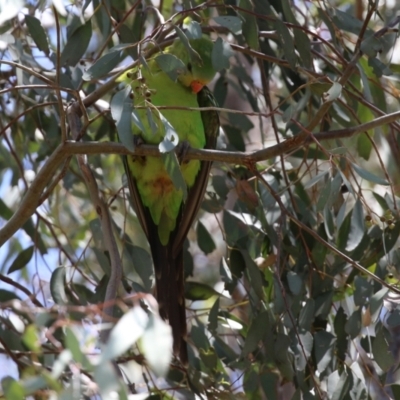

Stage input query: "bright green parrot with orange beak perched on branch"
[{"left": 120, "top": 36, "right": 219, "bottom": 363}]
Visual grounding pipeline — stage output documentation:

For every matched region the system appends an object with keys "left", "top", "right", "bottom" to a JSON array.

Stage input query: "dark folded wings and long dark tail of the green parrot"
[{"left": 124, "top": 87, "right": 220, "bottom": 363}]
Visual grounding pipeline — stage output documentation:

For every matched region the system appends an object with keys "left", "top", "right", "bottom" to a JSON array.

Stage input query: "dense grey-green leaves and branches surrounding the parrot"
[{"left": 0, "top": 0, "right": 400, "bottom": 400}]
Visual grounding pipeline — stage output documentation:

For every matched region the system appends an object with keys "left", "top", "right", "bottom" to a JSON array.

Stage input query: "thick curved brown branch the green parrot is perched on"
[{"left": 0, "top": 111, "right": 400, "bottom": 247}]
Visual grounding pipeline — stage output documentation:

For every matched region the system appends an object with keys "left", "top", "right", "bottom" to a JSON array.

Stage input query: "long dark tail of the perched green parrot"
[{"left": 149, "top": 232, "right": 188, "bottom": 364}]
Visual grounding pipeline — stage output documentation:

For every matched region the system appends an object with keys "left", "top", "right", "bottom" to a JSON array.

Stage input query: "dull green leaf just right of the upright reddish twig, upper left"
[{"left": 61, "top": 20, "right": 92, "bottom": 67}]
